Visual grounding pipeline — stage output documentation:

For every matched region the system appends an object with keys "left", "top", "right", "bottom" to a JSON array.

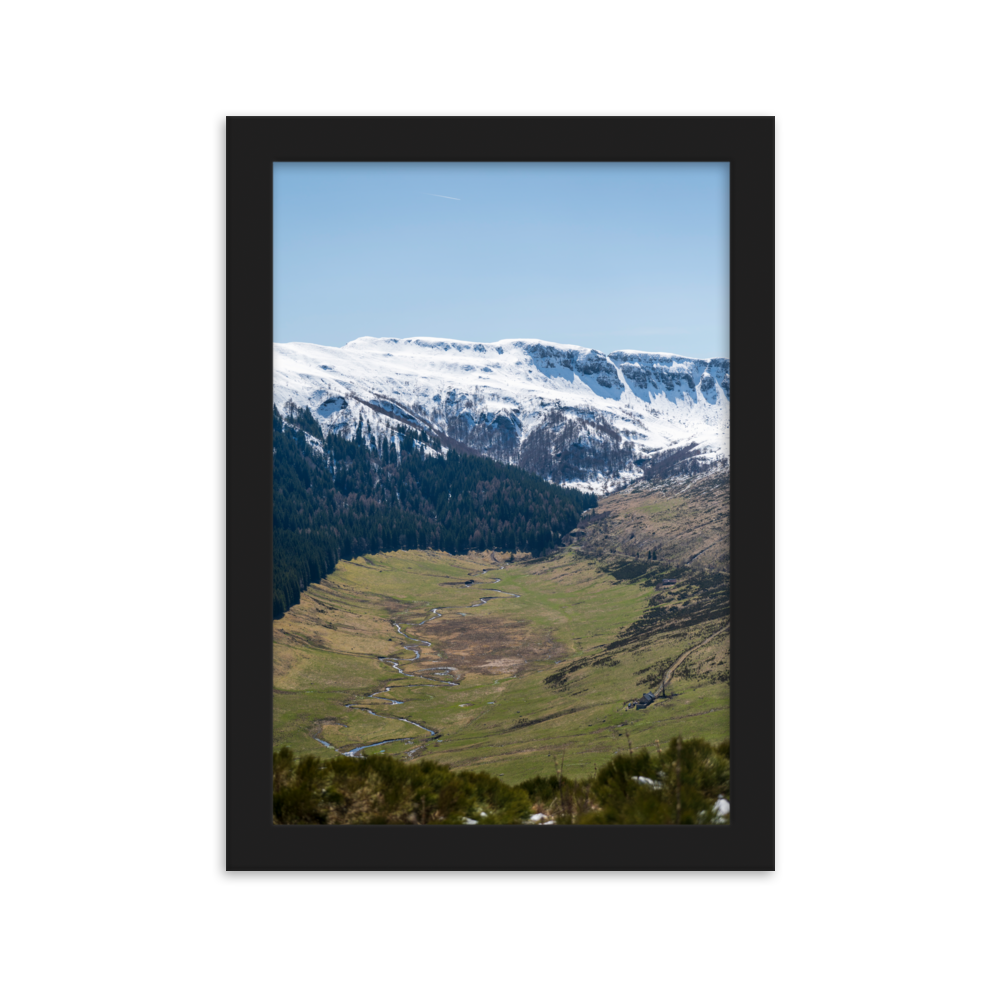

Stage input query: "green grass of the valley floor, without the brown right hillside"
[{"left": 274, "top": 550, "right": 729, "bottom": 783}]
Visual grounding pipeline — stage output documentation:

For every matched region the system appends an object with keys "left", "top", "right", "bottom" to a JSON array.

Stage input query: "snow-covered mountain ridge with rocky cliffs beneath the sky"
[{"left": 274, "top": 337, "right": 730, "bottom": 492}]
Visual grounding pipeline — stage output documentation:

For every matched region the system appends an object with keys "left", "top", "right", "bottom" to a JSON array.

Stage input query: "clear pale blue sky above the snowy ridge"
[{"left": 274, "top": 163, "right": 729, "bottom": 358}]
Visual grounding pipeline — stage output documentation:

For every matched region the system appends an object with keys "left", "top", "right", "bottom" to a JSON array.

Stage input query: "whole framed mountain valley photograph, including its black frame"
[{"left": 227, "top": 118, "right": 774, "bottom": 870}]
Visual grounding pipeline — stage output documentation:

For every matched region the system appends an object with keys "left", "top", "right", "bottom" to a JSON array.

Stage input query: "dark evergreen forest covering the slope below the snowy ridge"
[{"left": 272, "top": 404, "right": 597, "bottom": 618}]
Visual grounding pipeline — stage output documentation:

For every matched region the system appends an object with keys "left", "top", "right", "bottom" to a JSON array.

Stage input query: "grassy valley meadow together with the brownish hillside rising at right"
[{"left": 273, "top": 474, "right": 729, "bottom": 784}]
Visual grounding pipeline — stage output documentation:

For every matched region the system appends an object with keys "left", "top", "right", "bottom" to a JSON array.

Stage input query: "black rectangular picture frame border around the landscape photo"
[{"left": 226, "top": 116, "right": 775, "bottom": 871}]
